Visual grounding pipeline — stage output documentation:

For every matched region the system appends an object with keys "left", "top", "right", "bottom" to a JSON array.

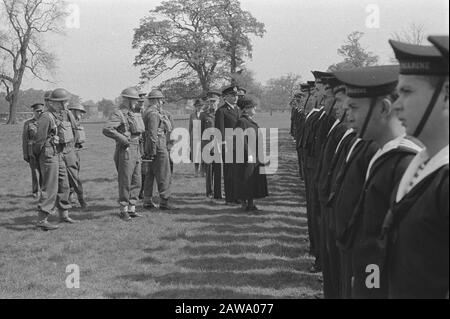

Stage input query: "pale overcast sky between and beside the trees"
[{"left": 20, "top": 0, "right": 449, "bottom": 101}]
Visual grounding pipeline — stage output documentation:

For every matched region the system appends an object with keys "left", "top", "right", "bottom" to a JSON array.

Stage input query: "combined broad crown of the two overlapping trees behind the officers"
[{"left": 132, "top": 0, "right": 265, "bottom": 92}]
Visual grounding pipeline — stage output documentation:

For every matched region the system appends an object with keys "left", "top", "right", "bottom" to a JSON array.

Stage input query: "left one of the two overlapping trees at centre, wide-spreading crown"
[{"left": 132, "top": 0, "right": 225, "bottom": 91}]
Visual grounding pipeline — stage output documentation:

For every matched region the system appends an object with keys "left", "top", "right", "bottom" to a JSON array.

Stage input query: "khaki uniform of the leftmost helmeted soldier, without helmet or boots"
[{"left": 33, "top": 112, "right": 71, "bottom": 214}]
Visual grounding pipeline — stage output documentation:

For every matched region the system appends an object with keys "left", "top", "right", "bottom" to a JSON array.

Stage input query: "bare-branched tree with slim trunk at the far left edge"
[{"left": 0, "top": 0, "right": 66, "bottom": 124}]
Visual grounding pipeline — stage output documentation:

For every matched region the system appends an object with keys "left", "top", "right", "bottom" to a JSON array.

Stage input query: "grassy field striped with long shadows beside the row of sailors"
[{"left": 0, "top": 113, "right": 321, "bottom": 298}]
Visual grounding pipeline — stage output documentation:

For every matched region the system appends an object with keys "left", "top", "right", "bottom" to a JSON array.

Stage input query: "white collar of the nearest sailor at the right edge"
[{"left": 396, "top": 145, "right": 449, "bottom": 202}]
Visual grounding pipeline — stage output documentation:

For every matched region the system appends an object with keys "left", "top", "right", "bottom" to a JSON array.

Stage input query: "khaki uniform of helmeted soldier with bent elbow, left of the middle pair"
[{"left": 103, "top": 106, "right": 141, "bottom": 207}]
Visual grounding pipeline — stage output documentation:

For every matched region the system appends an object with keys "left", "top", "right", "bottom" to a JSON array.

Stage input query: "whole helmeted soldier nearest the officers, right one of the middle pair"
[{"left": 144, "top": 90, "right": 174, "bottom": 210}]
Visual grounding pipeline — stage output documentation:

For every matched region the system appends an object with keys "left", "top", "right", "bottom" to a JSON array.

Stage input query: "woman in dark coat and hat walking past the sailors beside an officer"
[{"left": 233, "top": 97, "right": 268, "bottom": 211}]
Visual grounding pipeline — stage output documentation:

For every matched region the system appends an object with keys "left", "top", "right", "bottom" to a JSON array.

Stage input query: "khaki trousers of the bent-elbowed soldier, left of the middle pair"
[{"left": 114, "top": 144, "right": 141, "bottom": 207}]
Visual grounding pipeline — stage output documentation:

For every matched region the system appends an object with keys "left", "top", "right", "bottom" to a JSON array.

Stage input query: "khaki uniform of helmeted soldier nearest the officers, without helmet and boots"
[{"left": 144, "top": 106, "right": 172, "bottom": 205}]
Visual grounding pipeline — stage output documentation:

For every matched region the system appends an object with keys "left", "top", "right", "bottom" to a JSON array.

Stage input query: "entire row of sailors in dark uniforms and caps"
[{"left": 291, "top": 36, "right": 449, "bottom": 298}]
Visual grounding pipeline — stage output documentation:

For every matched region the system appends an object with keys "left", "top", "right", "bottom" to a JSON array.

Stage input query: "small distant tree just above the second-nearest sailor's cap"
[{"left": 328, "top": 31, "right": 379, "bottom": 72}]
